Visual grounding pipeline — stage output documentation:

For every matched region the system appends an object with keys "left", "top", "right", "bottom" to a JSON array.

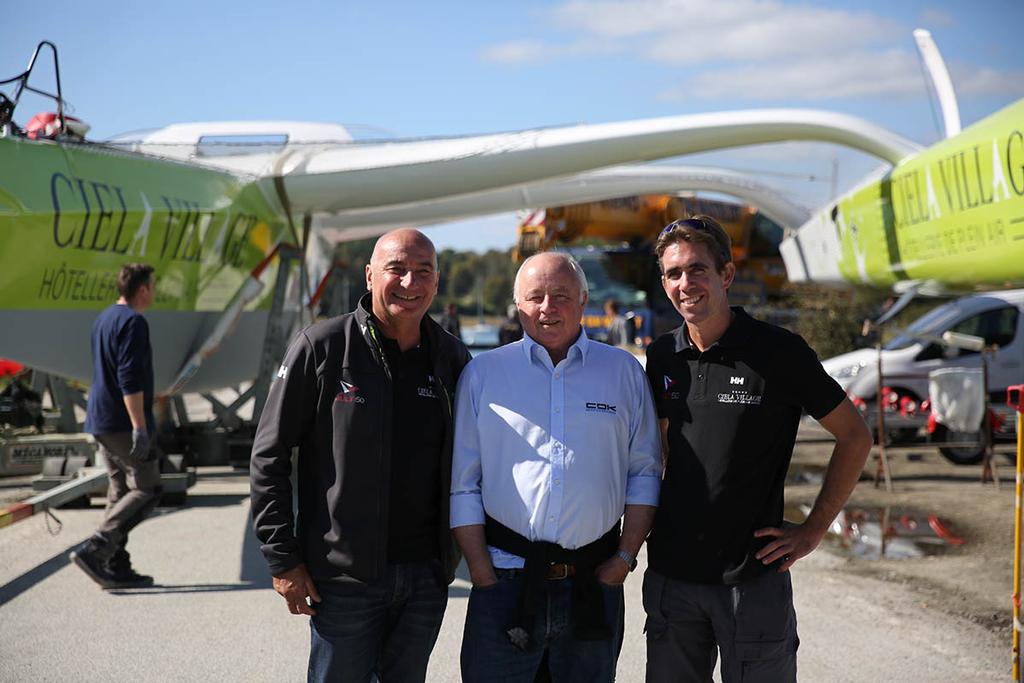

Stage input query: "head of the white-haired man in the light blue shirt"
[{"left": 516, "top": 254, "right": 587, "bottom": 364}]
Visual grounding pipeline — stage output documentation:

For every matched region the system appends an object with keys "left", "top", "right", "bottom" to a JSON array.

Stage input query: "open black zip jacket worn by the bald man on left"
[{"left": 251, "top": 295, "right": 470, "bottom": 583}]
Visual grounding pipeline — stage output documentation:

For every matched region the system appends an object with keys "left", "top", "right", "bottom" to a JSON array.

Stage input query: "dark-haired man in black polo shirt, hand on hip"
[{"left": 643, "top": 217, "right": 871, "bottom": 683}]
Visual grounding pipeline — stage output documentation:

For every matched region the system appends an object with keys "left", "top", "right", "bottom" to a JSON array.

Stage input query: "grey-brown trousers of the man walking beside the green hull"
[{"left": 95, "top": 432, "right": 161, "bottom": 557}]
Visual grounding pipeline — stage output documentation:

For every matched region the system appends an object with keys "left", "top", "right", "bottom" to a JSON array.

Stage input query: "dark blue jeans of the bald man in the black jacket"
[{"left": 308, "top": 561, "right": 447, "bottom": 683}]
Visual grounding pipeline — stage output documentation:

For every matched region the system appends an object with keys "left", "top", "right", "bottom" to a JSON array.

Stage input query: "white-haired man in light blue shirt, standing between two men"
[{"left": 452, "top": 252, "right": 662, "bottom": 683}]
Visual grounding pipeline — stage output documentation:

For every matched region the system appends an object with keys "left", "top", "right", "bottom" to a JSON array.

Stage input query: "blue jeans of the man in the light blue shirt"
[{"left": 462, "top": 569, "right": 624, "bottom": 683}]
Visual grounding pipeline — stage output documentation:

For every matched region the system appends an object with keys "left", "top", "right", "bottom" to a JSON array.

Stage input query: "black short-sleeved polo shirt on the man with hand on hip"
[{"left": 647, "top": 307, "right": 846, "bottom": 584}]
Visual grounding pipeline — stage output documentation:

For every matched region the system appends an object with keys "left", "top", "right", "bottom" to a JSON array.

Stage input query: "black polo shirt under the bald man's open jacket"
[{"left": 383, "top": 337, "right": 445, "bottom": 562}]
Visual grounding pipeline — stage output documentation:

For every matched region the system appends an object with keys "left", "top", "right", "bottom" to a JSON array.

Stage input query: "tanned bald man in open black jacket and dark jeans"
[{"left": 252, "top": 229, "right": 469, "bottom": 681}]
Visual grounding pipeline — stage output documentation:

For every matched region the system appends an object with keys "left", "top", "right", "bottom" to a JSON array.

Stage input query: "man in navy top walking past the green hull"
[{"left": 70, "top": 263, "right": 161, "bottom": 588}]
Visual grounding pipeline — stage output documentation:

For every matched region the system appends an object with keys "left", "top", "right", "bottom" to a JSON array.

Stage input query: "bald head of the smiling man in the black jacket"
[{"left": 367, "top": 229, "right": 437, "bottom": 333}]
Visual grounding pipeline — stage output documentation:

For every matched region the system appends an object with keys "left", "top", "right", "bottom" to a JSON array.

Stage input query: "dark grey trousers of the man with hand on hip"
[{"left": 643, "top": 569, "right": 800, "bottom": 683}]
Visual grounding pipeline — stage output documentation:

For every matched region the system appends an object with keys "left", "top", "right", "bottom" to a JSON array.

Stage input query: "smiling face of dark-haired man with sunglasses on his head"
[{"left": 662, "top": 241, "right": 736, "bottom": 328}]
